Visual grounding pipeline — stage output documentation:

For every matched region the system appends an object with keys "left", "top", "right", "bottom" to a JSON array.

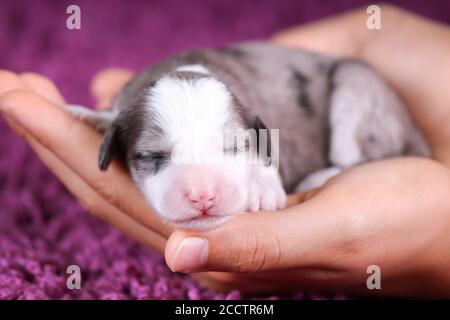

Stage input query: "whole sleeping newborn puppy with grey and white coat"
[{"left": 67, "top": 42, "right": 428, "bottom": 229}]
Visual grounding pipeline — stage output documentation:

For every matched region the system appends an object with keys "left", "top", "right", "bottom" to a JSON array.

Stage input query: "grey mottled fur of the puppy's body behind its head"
[{"left": 67, "top": 42, "right": 429, "bottom": 192}]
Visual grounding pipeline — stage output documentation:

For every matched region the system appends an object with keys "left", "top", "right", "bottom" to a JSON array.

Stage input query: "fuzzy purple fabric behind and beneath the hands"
[{"left": 0, "top": 0, "right": 450, "bottom": 299}]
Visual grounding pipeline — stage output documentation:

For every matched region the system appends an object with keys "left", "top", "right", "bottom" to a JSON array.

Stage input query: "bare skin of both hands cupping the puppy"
[{"left": 0, "top": 6, "right": 450, "bottom": 297}]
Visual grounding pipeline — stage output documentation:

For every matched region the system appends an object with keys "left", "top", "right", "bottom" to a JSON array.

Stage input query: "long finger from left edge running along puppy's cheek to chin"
[{"left": 0, "top": 90, "right": 170, "bottom": 238}]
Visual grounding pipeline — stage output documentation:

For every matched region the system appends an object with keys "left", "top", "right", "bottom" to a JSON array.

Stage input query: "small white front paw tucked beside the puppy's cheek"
[{"left": 248, "top": 169, "right": 286, "bottom": 212}]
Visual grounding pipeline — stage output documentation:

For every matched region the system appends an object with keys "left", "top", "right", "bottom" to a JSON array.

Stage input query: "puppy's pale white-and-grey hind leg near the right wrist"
[{"left": 329, "top": 63, "right": 408, "bottom": 168}]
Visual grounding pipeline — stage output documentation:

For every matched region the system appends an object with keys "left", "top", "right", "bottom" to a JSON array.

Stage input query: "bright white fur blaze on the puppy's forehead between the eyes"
[{"left": 148, "top": 76, "right": 232, "bottom": 163}]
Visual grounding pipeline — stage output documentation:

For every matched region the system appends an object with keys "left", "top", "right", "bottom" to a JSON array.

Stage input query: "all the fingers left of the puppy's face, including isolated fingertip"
[{"left": 0, "top": 70, "right": 171, "bottom": 253}]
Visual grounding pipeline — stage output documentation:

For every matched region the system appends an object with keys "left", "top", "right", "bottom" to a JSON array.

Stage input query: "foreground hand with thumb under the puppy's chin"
[{"left": 165, "top": 158, "right": 450, "bottom": 297}]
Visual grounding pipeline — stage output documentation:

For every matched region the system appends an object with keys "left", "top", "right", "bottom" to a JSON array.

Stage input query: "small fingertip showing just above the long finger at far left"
[{"left": 19, "top": 72, "right": 65, "bottom": 106}]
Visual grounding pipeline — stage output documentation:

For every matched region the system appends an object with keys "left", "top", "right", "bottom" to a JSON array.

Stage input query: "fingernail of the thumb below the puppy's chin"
[{"left": 172, "top": 237, "right": 208, "bottom": 273}]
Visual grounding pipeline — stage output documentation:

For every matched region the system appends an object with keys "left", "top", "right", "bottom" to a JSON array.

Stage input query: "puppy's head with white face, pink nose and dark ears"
[{"left": 99, "top": 70, "right": 266, "bottom": 229}]
